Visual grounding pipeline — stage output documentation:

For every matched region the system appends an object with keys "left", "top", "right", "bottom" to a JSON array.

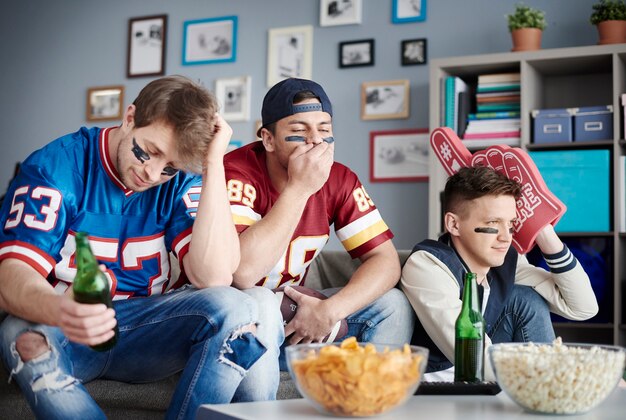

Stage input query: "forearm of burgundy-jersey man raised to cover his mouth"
[{"left": 233, "top": 188, "right": 309, "bottom": 289}]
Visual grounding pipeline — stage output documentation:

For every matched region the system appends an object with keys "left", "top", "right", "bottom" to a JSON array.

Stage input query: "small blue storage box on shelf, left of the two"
[{"left": 531, "top": 108, "right": 573, "bottom": 144}]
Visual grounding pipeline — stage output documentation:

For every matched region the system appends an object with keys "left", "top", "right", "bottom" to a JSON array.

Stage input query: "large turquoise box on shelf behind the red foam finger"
[{"left": 529, "top": 150, "right": 611, "bottom": 232}]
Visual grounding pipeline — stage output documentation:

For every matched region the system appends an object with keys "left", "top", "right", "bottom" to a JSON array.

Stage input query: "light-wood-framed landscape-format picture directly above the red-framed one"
[{"left": 361, "top": 80, "right": 409, "bottom": 120}]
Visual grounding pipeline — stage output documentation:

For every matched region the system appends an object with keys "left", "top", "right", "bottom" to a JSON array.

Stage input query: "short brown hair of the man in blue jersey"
[{"left": 133, "top": 76, "right": 217, "bottom": 173}]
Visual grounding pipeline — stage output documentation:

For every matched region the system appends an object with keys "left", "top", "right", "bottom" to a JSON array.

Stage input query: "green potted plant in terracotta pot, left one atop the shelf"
[{"left": 506, "top": 3, "right": 548, "bottom": 51}]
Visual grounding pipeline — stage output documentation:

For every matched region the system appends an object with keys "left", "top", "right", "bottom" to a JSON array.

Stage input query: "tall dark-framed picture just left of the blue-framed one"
[{"left": 126, "top": 15, "right": 167, "bottom": 77}]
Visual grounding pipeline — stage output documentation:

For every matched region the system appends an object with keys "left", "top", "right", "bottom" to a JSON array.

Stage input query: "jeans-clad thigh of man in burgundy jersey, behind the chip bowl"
[{"left": 272, "top": 288, "right": 415, "bottom": 371}]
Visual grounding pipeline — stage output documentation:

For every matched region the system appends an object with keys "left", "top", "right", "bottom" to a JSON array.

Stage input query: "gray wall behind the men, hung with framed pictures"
[{"left": 0, "top": 0, "right": 597, "bottom": 248}]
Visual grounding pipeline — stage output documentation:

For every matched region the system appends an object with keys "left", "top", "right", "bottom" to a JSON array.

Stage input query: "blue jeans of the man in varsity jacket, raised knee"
[{"left": 487, "top": 285, "right": 555, "bottom": 343}]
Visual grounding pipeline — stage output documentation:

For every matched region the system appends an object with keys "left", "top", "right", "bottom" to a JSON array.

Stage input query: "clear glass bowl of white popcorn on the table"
[{"left": 489, "top": 339, "right": 626, "bottom": 414}]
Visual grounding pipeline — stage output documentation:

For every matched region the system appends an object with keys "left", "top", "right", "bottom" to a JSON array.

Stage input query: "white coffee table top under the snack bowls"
[{"left": 196, "top": 388, "right": 626, "bottom": 420}]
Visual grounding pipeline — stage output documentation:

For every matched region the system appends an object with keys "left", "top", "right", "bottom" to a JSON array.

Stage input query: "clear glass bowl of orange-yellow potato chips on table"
[{"left": 285, "top": 337, "right": 428, "bottom": 417}]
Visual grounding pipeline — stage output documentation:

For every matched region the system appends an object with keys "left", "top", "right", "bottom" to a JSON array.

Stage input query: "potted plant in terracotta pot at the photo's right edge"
[{"left": 589, "top": 0, "right": 626, "bottom": 44}]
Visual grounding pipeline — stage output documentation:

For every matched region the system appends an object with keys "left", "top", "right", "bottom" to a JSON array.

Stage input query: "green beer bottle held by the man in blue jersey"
[{"left": 72, "top": 232, "right": 119, "bottom": 351}]
